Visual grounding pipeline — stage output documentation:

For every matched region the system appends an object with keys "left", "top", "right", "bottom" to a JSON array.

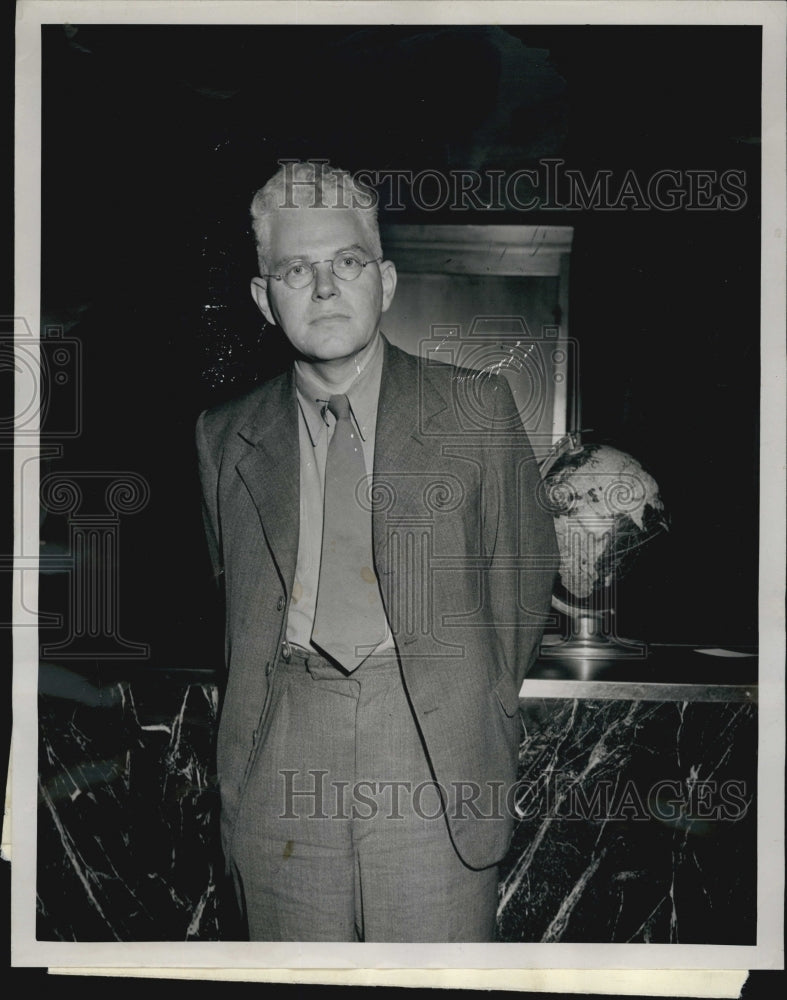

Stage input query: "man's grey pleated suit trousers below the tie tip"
[{"left": 230, "top": 643, "right": 498, "bottom": 942}]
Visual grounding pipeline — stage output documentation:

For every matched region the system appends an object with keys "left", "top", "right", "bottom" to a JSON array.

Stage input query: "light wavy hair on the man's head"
[{"left": 251, "top": 160, "right": 383, "bottom": 274}]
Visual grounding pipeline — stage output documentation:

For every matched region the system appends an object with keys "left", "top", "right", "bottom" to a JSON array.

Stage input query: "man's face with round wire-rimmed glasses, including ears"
[{"left": 251, "top": 208, "right": 396, "bottom": 361}]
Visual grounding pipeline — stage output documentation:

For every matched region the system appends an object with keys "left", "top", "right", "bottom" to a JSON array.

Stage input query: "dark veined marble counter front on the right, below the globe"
[{"left": 499, "top": 700, "right": 757, "bottom": 944}]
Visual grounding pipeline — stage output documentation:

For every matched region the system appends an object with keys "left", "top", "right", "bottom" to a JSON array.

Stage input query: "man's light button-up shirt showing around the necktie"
[{"left": 286, "top": 333, "right": 394, "bottom": 653}]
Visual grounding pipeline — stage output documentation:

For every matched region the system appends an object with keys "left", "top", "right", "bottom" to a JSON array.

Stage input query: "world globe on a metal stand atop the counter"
[{"left": 541, "top": 434, "right": 668, "bottom": 658}]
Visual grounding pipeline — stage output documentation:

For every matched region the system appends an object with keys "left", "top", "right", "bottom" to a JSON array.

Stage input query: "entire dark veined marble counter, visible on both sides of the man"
[{"left": 37, "top": 664, "right": 757, "bottom": 944}]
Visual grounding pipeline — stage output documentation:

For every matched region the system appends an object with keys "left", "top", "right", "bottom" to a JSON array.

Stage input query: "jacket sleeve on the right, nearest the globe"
[{"left": 484, "top": 375, "right": 559, "bottom": 689}]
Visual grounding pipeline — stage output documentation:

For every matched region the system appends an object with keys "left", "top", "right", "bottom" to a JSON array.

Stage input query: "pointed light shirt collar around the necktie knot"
[{"left": 294, "top": 332, "right": 383, "bottom": 446}]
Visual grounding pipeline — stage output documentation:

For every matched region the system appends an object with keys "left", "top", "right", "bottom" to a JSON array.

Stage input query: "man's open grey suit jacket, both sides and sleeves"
[{"left": 197, "top": 341, "right": 557, "bottom": 868}]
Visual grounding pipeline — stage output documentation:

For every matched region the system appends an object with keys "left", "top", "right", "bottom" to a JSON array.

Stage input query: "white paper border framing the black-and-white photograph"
[{"left": 12, "top": 0, "right": 787, "bottom": 969}]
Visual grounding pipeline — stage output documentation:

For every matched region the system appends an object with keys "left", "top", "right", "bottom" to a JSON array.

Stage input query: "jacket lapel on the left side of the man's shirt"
[{"left": 237, "top": 370, "right": 300, "bottom": 595}]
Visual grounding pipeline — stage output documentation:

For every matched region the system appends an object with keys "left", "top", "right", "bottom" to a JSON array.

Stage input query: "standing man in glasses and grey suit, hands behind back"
[{"left": 197, "top": 163, "right": 556, "bottom": 941}]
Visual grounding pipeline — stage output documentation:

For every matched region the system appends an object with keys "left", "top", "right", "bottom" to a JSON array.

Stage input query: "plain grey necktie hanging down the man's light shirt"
[{"left": 312, "top": 395, "right": 386, "bottom": 671}]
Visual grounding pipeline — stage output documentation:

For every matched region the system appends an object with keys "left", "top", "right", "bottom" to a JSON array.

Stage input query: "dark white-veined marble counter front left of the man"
[{"left": 37, "top": 665, "right": 232, "bottom": 941}]
